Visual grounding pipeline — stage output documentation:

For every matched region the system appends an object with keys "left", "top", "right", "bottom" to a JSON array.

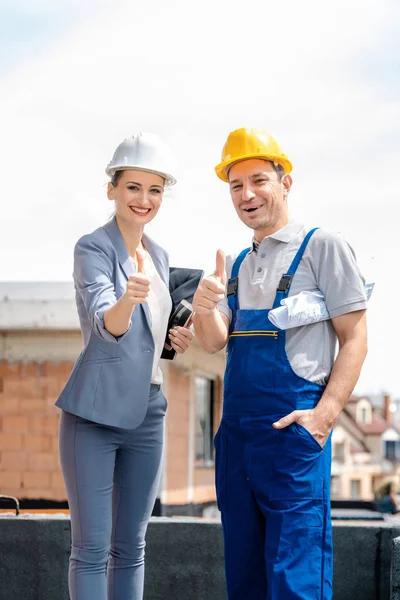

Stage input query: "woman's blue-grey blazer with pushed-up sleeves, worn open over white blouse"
[{"left": 56, "top": 217, "right": 169, "bottom": 429}]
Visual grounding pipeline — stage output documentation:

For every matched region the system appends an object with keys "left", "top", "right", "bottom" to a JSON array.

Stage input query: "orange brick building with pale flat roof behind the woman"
[{"left": 0, "top": 282, "right": 225, "bottom": 515}]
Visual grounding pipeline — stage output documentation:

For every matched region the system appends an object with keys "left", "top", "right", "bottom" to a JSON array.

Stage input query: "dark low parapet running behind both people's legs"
[{"left": 0, "top": 514, "right": 400, "bottom": 600}]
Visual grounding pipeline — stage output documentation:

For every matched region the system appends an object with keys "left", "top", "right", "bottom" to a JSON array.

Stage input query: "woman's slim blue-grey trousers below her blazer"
[{"left": 59, "top": 386, "right": 167, "bottom": 600}]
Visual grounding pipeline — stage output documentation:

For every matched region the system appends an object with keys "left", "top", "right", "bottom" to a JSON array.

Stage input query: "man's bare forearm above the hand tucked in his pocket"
[{"left": 315, "top": 338, "right": 367, "bottom": 428}]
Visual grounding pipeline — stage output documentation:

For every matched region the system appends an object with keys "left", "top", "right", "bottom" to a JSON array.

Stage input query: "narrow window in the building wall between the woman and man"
[{"left": 195, "top": 377, "right": 215, "bottom": 467}]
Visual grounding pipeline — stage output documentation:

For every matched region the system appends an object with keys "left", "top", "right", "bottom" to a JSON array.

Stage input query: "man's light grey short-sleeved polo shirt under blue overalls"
[{"left": 219, "top": 222, "right": 367, "bottom": 385}]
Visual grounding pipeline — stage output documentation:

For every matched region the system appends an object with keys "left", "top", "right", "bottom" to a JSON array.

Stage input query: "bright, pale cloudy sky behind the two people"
[{"left": 0, "top": 0, "right": 400, "bottom": 397}]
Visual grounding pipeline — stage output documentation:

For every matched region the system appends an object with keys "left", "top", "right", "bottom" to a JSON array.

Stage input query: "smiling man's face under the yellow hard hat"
[{"left": 229, "top": 158, "right": 292, "bottom": 241}]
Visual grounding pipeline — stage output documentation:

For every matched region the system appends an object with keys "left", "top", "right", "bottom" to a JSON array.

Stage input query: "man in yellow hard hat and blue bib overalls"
[{"left": 193, "top": 129, "right": 367, "bottom": 600}]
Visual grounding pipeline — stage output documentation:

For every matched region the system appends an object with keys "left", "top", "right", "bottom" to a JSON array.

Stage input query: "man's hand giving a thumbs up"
[{"left": 192, "top": 250, "right": 226, "bottom": 315}]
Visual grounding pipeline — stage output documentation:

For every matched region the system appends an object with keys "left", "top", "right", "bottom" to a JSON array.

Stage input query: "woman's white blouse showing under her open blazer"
[{"left": 141, "top": 252, "right": 172, "bottom": 385}]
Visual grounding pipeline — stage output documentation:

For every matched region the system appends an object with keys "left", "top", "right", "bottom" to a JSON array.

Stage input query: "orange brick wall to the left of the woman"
[{"left": 0, "top": 361, "right": 73, "bottom": 500}]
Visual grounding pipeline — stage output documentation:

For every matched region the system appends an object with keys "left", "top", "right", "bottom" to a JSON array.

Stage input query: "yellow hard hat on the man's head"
[{"left": 215, "top": 127, "right": 292, "bottom": 181}]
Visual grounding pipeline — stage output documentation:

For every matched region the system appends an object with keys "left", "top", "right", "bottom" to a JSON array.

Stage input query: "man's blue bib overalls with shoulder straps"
[{"left": 215, "top": 230, "right": 332, "bottom": 600}]
